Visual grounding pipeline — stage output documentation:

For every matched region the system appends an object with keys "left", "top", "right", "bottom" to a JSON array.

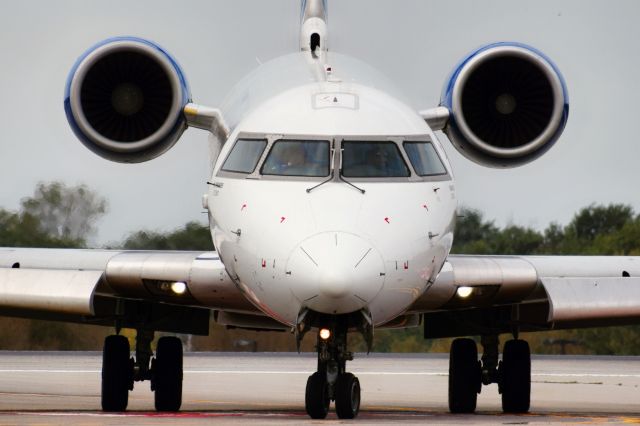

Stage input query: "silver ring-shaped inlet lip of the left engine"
[{"left": 69, "top": 40, "right": 182, "bottom": 154}]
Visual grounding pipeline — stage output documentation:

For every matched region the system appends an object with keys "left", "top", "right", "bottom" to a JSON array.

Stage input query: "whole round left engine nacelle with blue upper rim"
[{"left": 64, "top": 37, "right": 191, "bottom": 163}]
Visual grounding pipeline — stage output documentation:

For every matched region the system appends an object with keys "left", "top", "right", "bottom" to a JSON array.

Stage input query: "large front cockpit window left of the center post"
[{"left": 261, "top": 139, "right": 329, "bottom": 177}]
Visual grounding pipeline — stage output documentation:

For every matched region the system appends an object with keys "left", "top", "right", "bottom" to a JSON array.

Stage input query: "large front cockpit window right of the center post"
[{"left": 342, "top": 141, "right": 410, "bottom": 178}]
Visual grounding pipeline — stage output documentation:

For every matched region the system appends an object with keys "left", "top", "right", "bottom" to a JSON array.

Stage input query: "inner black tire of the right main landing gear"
[{"left": 449, "top": 339, "right": 482, "bottom": 413}]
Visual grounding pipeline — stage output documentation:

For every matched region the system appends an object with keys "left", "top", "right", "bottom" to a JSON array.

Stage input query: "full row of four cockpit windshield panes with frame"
[{"left": 220, "top": 135, "right": 449, "bottom": 183}]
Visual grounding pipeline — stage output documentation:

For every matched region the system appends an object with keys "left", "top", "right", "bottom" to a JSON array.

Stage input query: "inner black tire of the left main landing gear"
[{"left": 152, "top": 336, "right": 182, "bottom": 411}]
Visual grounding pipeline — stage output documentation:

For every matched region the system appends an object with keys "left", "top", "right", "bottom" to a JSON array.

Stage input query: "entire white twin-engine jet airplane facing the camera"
[{"left": 0, "top": 0, "right": 640, "bottom": 418}]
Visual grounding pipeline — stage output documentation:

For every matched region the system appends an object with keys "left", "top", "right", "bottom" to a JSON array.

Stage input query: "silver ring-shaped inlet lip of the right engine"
[{"left": 452, "top": 46, "right": 565, "bottom": 158}]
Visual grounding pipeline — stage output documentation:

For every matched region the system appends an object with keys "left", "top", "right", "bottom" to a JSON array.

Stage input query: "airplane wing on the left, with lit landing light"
[{"left": 0, "top": 248, "right": 261, "bottom": 334}]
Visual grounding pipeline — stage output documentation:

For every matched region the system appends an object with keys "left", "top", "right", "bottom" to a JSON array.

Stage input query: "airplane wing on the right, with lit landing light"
[{"left": 410, "top": 255, "right": 640, "bottom": 337}]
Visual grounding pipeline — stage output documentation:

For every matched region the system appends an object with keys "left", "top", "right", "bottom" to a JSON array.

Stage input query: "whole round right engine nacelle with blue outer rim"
[{"left": 441, "top": 43, "right": 569, "bottom": 167}]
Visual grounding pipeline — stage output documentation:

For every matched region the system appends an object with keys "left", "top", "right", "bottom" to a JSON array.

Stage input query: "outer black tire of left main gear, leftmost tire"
[{"left": 101, "top": 335, "right": 133, "bottom": 411}]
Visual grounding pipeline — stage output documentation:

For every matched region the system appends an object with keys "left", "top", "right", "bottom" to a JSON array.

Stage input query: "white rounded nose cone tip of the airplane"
[{"left": 287, "top": 232, "right": 384, "bottom": 314}]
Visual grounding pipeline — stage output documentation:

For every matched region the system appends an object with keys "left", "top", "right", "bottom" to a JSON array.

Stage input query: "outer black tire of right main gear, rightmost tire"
[{"left": 500, "top": 340, "right": 531, "bottom": 413}]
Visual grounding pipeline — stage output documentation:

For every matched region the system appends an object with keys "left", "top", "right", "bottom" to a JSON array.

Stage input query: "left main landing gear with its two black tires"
[{"left": 102, "top": 330, "right": 182, "bottom": 411}]
